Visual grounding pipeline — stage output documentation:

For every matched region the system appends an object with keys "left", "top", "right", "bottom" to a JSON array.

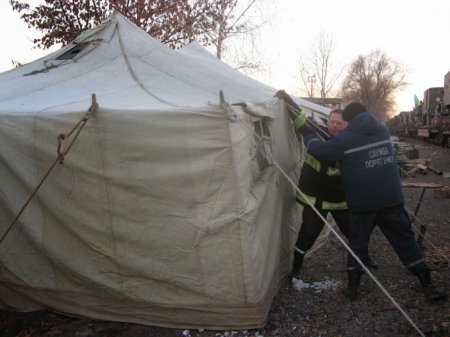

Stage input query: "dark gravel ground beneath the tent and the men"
[{"left": 0, "top": 139, "right": 450, "bottom": 337}]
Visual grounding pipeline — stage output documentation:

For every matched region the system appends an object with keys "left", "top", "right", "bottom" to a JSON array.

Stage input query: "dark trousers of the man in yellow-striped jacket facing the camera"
[{"left": 296, "top": 205, "right": 348, "bottom": 252}]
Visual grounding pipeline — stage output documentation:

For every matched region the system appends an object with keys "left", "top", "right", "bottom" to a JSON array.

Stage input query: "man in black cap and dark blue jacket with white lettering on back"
[{"left": 295, "top": 102, "right": 447, "bottom": 301}]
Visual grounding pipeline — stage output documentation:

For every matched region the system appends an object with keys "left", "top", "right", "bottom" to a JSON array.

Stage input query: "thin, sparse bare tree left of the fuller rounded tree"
[{"left": 299, "top": 32, "right": 344, "bottom": 98}]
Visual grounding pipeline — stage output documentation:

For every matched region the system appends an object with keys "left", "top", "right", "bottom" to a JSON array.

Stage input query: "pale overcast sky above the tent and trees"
[{"left": 0, "top": 0, "right": 450, "bottom": 111}]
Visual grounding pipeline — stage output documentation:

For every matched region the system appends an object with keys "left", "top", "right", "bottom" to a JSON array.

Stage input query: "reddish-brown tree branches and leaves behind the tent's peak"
[{"left": 10, "top": 0, "right": 256, "bottom": 53}]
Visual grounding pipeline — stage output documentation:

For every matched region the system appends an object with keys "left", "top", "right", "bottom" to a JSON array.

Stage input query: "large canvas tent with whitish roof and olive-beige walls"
[{"left": 0, "top": 13, "right": 326, "bottom": 328}]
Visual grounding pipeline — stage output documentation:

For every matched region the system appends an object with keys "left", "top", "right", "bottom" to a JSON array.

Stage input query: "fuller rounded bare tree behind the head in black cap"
[{"left": 341, "top": 50, "right": 408, "bottom": 121}]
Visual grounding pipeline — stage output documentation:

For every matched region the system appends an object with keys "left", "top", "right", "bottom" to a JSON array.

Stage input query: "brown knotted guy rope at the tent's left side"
[{"left": 0, "top": 94, "right": 98, "bottom": 244}]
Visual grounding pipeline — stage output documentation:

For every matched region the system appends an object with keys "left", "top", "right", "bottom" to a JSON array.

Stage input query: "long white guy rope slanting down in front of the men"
[{"left": 237, "top": 105, "right": 426, "bottom": 337}]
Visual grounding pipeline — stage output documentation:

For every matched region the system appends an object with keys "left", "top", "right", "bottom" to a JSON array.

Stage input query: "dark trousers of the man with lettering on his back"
[{"left": 347, "top": 205, "right": 428, "bottom": 275}]
